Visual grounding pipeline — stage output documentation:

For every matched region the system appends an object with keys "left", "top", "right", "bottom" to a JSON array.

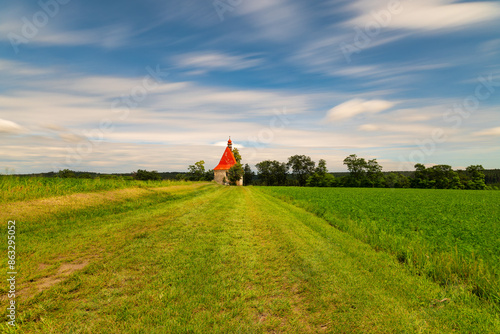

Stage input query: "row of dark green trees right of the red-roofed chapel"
[{"left": 252, "top": 154, "right": 496, "bottom": 189}]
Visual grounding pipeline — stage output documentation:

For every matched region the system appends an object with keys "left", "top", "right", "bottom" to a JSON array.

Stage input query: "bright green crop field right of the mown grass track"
[{"left": 260, "top": 187, "right": 500, "bottom": 305}]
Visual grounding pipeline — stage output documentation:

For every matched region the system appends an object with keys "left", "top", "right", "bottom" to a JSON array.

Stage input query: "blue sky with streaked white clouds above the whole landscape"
[{"left": 0, "top": 0, "right": 500, "bottom": 173}]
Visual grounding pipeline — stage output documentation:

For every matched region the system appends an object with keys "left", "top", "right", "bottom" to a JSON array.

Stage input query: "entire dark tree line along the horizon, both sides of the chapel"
[{"left": 31, "top": 148, "right": 500, "bottom": 189}]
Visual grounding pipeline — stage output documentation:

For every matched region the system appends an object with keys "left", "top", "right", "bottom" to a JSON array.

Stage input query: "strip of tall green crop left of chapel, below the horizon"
[{"left": 0, "top": 175, "right": 191, "bottom": 203}]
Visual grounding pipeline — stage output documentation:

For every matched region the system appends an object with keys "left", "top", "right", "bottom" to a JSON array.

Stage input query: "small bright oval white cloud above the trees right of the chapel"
[{"left": 326, "top": 99, "right": 395, "bottom": 122}]
